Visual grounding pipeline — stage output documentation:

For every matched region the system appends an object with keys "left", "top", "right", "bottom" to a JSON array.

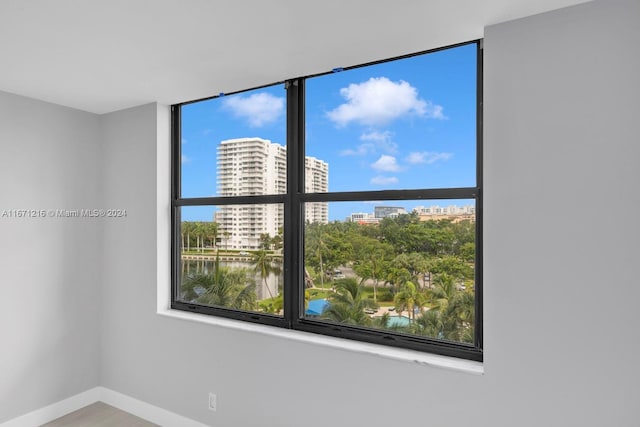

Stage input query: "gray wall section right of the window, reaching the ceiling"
[{"left": 480, "top": 0, "right": 640, "bottom": 426}]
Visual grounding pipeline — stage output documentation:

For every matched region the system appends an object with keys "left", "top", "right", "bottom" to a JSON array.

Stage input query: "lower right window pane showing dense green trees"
[{"left": 304, "top": 200, "right": 476, "bottom": 343}]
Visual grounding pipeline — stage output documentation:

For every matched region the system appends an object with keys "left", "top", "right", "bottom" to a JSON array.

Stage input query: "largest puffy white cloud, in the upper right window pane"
[{"left": 327, "top": 77, "right": 444, "bottom": 126}]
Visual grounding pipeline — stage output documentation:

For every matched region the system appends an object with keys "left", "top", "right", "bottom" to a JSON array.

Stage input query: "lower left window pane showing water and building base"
[{"left": 179, "top": 203, "right": 284, "bottom": 315}]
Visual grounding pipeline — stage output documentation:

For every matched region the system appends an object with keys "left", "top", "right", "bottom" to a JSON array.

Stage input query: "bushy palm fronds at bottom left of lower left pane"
[{"left": 182, "top": 257, "right": 256, "bottom": 310}]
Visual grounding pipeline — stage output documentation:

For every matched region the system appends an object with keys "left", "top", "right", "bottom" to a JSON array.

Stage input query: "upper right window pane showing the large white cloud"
[{"left": 305, "top": 44, "right": 476, "bottom": 192}]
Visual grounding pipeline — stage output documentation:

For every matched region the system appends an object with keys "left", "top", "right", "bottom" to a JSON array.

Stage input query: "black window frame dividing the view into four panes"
[{"left": 171, "top": 39, "right": 483, "bottom": 361}]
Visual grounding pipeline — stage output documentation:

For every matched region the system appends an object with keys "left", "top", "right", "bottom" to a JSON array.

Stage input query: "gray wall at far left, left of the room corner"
[{"left": 0, "top": 92, "right": 102, "bottom": 423}]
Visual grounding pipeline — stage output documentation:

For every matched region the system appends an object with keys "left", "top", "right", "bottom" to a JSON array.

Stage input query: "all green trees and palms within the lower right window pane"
[{"left": 305, "top": 214, "right": 475, "bottom": 342}]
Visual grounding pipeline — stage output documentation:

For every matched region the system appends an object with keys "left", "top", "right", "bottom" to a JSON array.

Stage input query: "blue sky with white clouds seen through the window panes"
[{"left": 182, "top": 44, "right": 476, "bottom": 221}]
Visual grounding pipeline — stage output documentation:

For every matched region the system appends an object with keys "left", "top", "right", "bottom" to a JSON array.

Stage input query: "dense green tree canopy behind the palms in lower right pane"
[{"left": 305, "top": 214, "right": 475, "bottom": 299}]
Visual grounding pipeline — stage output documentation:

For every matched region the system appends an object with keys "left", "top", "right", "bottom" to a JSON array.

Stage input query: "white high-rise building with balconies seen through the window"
[{"left": 214, "top": 138, "right": 328, "bottom": 249}]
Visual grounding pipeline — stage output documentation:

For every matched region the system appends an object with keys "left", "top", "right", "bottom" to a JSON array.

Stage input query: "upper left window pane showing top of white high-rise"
[{"left": 181, "top": 85, "right": 287, "bottom": 197}]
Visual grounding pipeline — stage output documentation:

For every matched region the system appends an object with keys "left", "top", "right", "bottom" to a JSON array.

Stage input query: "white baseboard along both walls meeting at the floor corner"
[{"left": 0, "top": 387, "right": 208, "bottom": 427}]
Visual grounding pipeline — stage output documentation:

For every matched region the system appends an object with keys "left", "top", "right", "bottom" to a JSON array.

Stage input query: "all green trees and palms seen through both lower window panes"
[{"left": 182, "top": 214, "right": 475, "bottom": 342}]
